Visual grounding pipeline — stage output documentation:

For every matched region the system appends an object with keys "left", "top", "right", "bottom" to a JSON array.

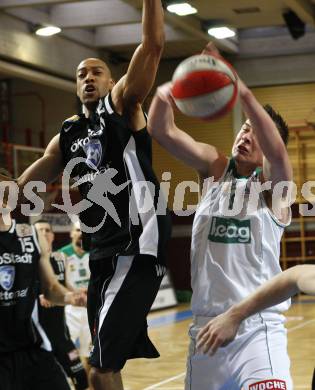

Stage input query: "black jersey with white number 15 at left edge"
[{"left": 0, "top": 221, "right": 42, "bottom": 353}]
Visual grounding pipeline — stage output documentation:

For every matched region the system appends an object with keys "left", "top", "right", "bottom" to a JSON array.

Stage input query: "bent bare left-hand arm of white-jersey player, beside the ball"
[{"left": 148, "top": 83, "right": 227, "bottom": 179}]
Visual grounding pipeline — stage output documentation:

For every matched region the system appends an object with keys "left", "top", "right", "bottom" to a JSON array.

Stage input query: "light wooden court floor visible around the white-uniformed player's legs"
[{"left": 123, "top": 296, "right": 315, "bottom": 390}]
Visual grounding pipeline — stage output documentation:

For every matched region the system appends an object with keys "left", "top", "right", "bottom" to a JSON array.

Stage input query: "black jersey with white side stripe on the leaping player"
[{"left": 60, "top": 94, "right": 170, "bottom": 259}]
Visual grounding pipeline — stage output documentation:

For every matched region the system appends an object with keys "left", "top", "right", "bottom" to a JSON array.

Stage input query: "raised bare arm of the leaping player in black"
[{"left": 112, "top": 0, "right": 164, "bottom": 110}]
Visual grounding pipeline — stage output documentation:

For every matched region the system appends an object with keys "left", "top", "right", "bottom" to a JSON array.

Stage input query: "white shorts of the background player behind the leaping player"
[{"left": 66, "top": 305, "right": 91, "bottom": 357}]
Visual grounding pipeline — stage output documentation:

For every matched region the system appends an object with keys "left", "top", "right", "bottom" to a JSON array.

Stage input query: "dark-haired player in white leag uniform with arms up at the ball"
[{"left": 148, "top": 45, "right": 292, "bottom": 390}]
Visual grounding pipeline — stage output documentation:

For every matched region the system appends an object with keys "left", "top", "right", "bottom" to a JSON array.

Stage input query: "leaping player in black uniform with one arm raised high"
[{"left": 2, "top": 0, "right": 170, "bottom": 390}]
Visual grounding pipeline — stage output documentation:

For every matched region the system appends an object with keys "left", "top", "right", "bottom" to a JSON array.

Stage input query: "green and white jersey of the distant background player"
[{"left": 59, "top": 244, "right": 90, "bottom": 289}]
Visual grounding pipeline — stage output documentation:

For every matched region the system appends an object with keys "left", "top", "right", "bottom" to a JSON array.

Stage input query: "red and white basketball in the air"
[{"left": 171, "top": 54, "right": 238, "bottom": 120}]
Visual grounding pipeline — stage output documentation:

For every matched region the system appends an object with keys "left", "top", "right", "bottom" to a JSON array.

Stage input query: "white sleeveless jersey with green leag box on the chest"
[{"left": 191, "top": 159, "right": 290, "bottom": 317}]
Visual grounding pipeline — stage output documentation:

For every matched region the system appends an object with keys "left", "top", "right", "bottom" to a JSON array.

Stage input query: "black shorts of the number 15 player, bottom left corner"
[{"left": 0, "top": 348, "right": 70, "bottom": 390}]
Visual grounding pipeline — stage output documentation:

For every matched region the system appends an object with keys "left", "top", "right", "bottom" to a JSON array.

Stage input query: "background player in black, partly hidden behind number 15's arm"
[{"left": 34, "top": 220, "right": 89, "bottom": 390}]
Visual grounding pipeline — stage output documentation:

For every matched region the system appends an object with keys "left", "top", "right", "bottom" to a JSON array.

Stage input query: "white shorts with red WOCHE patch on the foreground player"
[{"left": 185, "top": 315, "right": 293, "bottom": 390}]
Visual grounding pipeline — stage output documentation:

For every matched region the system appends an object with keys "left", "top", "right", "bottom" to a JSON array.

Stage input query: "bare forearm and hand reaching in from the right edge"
[{"left": 197, "top": 265, "right": 315, "bottom": 355}]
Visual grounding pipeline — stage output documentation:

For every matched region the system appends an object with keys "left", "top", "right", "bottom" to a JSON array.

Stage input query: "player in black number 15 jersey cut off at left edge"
[{"left": 0, "top": 173, "right": 83, "bottom": 390}]
